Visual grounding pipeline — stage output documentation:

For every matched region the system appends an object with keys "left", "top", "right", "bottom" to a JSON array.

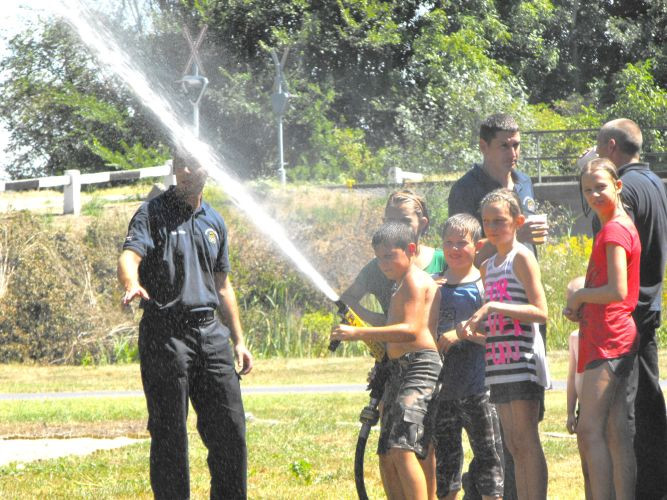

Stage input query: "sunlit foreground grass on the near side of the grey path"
[{"left": 0, "top": 392, "right": 582, "bottom": 499}]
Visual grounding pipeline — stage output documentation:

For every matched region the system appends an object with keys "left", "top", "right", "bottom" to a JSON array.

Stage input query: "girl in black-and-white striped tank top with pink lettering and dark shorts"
[{"left": 461, "top": 189, "right": 549, "bottom": 499}]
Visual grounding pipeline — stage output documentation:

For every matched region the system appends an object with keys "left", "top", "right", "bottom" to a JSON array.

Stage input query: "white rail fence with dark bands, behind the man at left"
[{"left": 0, "top": 160, "right": 176, "bottom": 215}]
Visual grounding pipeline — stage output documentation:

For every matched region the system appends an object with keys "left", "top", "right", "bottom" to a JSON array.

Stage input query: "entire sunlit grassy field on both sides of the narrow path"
[{"left": 0, "top": 352, "right": 667, "bottom": 499}]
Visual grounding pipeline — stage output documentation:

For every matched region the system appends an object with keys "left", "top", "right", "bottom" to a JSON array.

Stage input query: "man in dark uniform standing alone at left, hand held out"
[{"left": 118, "top": 152, "right": 252, "bottom": 499}]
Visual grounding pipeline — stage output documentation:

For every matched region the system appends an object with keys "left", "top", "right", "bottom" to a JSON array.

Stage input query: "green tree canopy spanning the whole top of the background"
[{"left": 0, "top": 0, "right": 667, "bottom": 181}]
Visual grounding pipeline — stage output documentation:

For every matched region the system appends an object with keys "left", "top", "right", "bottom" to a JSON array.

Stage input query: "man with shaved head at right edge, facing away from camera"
[{"left": 593, "top": 118, "right": 667, "bottom": 500}]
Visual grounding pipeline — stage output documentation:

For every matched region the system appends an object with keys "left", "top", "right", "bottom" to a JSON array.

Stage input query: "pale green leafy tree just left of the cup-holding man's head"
[{"left": 397, "top": 9, "right": 524, "bottom": 172}]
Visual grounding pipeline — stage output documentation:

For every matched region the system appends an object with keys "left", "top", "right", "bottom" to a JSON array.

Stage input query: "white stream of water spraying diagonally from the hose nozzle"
[{"left": 55, "top": 0, "right": 338, "bottom": 301}]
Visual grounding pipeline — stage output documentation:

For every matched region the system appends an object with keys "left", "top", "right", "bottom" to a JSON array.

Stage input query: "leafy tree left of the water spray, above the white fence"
[{"left": 0, "top": 22, "right": 165, "bottom": 178}]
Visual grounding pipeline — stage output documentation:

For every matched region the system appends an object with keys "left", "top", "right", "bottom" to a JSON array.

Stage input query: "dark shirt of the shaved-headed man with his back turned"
[{"left": 593, "top": 163, "right": 667, "bottom": 311}]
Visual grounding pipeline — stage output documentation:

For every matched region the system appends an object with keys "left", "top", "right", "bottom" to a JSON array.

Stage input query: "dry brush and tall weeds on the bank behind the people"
[{"left": 5, "top": 186, "right": 667, "bottom": 364}]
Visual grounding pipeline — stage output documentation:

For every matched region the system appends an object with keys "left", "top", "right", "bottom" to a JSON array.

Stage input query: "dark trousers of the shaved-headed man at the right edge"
[{"left": 628, "top": 307, "right": 667, "bottom": 500}]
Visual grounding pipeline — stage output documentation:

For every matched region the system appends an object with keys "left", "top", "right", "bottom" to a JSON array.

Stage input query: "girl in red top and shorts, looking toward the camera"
[{"left": 563, "top": 158, "right": 641, "bottom": 499}]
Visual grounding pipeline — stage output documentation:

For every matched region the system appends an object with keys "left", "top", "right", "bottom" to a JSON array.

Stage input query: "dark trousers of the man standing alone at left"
[{"left": 139, "top": 311, "right": 247, "bottom": 500}]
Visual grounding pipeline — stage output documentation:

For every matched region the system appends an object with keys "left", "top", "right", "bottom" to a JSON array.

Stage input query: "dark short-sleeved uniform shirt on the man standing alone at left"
[{"left": 123, "top": 187, "right": 229, "bottom": 311}]
